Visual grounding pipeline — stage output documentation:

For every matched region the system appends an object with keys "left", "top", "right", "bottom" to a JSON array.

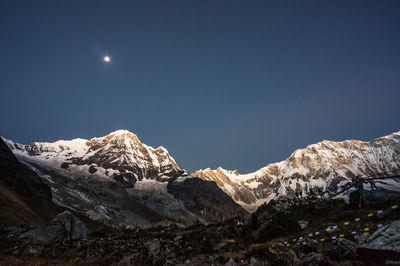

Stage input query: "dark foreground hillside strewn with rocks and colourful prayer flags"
[{"left": 0, "top": 191, "right": 400, "bottom": 265}]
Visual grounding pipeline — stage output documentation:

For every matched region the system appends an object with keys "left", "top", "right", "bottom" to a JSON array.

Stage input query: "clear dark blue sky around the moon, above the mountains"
[{"left": 0, "top": 0, "right": 400, "bottom": 173}]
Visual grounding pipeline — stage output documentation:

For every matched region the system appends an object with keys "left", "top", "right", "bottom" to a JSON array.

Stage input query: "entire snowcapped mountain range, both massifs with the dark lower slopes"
[{"left": 4, "top": 130, "right": 400, "bottom": 221}]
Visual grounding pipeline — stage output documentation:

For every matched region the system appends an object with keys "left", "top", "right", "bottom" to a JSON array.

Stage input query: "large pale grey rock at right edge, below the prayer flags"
[{"left": 360, "top": 221, "right": 400, "bottom": 251}]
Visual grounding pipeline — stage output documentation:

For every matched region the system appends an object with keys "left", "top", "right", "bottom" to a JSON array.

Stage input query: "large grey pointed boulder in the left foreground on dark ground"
[{"left": 19, "top": 211, "right": 88, "bottom": 245}]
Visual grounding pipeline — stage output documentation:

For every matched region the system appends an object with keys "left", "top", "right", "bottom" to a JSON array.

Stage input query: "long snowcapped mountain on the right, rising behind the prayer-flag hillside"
[{"left": 192, "top": 132, "right": 400, "bottom": 212}]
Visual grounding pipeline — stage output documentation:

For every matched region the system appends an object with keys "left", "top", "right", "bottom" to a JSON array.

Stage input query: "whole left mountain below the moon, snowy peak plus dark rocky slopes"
[{"left": 4, "top": 130, "right": 246, "bottom": 228}]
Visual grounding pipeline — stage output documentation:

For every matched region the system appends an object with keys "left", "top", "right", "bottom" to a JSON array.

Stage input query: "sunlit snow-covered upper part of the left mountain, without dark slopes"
[{"left": 3, "top": 130, "right": 184, "bottom": 183}]
